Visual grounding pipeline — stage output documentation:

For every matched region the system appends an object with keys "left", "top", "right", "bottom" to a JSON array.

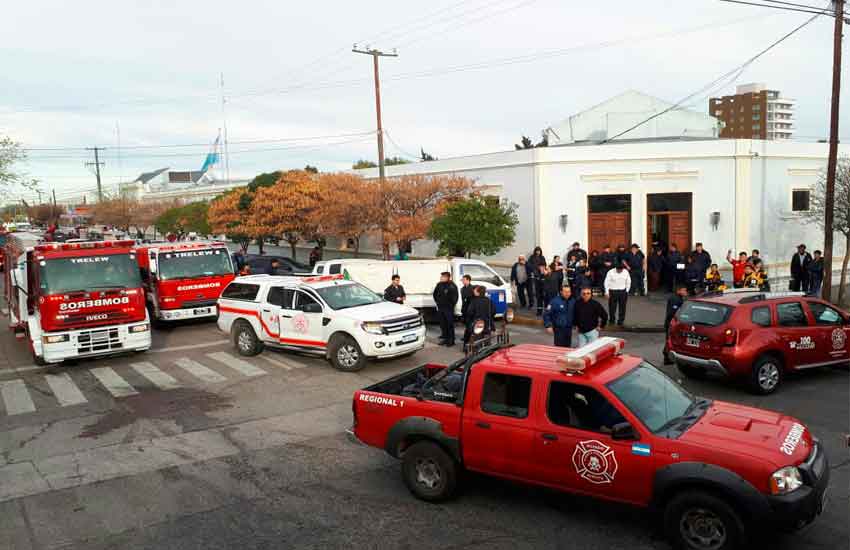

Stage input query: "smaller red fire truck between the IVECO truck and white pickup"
[{"left": 136, "top": 241, "right": 235, "bottom": 321}]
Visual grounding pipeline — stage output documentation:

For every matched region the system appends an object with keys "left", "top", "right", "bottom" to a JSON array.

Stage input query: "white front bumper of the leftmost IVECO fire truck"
[{"left": 41, "top": 321, "right": 151, "bottom": 363}]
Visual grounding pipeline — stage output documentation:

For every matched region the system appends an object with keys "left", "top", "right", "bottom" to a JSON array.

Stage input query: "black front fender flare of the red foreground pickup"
[{"left": 652, "top": 462, "right": 770, "bottom": 522}]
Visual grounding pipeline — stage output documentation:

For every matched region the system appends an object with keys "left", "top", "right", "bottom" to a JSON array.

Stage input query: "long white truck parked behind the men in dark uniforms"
[{"left": 313, "top": 258, "right": 513, "bottom": 317}]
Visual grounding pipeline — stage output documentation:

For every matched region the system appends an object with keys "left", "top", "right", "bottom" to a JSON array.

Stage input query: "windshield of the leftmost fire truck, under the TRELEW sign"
[{"left": 38, "top": 253, "right": 142, "bottom": 294}]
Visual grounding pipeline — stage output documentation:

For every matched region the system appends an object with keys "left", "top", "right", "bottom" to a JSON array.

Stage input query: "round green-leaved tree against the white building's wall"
[{"left": 428, "top": 195, "right": 519, "bottom": 257}]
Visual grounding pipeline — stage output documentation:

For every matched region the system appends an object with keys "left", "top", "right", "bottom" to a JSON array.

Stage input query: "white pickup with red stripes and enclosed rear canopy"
[{"left": 218, "top": 275, "right": 425, "bottom": 372}]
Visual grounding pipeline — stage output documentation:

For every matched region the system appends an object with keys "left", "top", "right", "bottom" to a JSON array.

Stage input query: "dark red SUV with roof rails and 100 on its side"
[{"left": 667, "top": 292, "right": 850, "bottom": 395}]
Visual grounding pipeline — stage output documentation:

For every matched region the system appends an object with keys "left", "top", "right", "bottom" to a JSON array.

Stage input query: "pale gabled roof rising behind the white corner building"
[{"left": 544, "top": 90, "right": 720, "bottom": 145}]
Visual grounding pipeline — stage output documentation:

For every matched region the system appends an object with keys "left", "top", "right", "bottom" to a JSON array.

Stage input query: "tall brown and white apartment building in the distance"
[{"left": 708, "top": 83, "right": 794, "bottom": 140}]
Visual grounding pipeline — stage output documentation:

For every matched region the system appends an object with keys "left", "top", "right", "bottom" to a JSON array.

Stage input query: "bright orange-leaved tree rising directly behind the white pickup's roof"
[{"left": 250, "top": 170, "right": 324, "bottom": 259}]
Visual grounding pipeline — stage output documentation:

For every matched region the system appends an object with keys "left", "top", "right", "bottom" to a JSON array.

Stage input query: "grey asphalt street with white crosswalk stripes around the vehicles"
[{"left": 0, "top": 314, "right": 850, "bottom": 550}]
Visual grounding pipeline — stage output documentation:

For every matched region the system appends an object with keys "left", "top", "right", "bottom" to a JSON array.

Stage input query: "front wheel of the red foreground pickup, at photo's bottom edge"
[{"left": 664, "top": 491, "right": 744, "bottom": 550}]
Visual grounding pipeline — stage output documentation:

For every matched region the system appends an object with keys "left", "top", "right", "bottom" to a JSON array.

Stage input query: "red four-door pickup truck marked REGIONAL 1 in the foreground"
[{"left": 352, "top": 338, "right": 829, "bottom": 550}]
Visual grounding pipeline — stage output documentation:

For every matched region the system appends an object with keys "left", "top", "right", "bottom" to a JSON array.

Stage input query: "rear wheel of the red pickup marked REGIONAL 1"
[{"left": 401, "top": 441, "right": 458, "bottom": 502}]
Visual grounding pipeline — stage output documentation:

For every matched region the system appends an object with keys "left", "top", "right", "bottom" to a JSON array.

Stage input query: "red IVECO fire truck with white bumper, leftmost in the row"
[{"left": 5, "top": 233, "right": 151, "bottom": 364}]
